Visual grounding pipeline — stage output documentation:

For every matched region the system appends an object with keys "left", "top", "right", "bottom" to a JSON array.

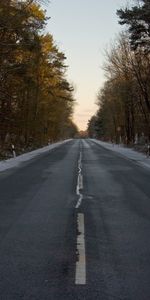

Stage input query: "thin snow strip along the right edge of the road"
[{"left": 91, "top": 139, "right": 150, "bottom": 168}]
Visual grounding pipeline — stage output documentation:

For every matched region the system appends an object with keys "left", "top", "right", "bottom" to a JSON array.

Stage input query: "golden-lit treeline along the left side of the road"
[{"left": 0, "top": 0, "right": 77, "bottom": 157}]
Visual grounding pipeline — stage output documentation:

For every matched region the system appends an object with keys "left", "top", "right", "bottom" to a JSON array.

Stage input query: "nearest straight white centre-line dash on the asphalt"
[{"left": 75, "top": 213, "right": 86, "bottom": 285}]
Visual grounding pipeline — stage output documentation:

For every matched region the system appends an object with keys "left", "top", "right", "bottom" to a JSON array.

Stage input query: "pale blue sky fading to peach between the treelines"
[{"left": 46, "top": 0, "right": 127, "bottom": 130}]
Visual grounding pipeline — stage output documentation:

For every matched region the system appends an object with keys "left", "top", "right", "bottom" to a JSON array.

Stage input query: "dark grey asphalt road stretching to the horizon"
[{"left": 0, "top": 140, "right": 150, "bottom": 300}]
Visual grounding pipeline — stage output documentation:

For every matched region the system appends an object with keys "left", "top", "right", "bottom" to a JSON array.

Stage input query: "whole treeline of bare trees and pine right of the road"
[{"left": 88, "top": 0, "right": 150, "bottom": 144}]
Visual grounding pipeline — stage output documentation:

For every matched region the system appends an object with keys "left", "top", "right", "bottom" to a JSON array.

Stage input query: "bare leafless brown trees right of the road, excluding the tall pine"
[{"left": 91, "top": 34, "right": 150, "bottom": 144}]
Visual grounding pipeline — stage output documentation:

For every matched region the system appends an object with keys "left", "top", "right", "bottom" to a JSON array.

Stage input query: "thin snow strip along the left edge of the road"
[{"left": 0, "top": 139, "right": 71, "bottom": 172}]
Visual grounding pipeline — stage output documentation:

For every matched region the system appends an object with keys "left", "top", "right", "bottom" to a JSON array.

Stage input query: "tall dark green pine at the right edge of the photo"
[{"left": 117, "top": 0, "right": 150, "bottom": 134}]
